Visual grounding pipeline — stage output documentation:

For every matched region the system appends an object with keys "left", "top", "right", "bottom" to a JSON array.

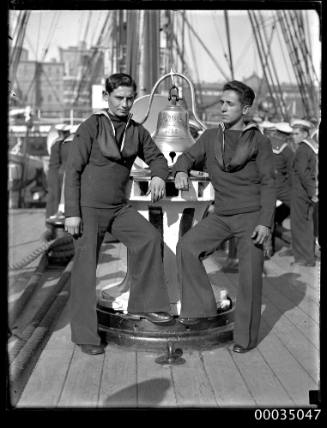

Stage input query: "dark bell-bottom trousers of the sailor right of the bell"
[{"left": 177, "top": 212, "right": 263, "bottom": 347}]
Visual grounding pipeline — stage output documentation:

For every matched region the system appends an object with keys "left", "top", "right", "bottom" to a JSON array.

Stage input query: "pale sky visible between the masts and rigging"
[{"left": 9, "top": 10, "right": 321, "bottom": 83}]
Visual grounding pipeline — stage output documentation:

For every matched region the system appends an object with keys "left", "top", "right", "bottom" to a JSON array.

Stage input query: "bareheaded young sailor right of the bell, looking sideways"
[{"left": 172, "top": 81, "right": 276, "bottom": 353}]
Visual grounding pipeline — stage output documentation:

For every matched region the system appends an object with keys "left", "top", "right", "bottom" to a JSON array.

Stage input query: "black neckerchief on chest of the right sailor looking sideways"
[{"left": 215, "top": 122, "right": 260, "bottom": 172}]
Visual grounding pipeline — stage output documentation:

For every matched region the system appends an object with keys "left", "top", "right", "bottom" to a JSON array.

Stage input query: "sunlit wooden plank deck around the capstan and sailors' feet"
[{"left": 17, "top": 237, "right": 320, "bottom": 408}]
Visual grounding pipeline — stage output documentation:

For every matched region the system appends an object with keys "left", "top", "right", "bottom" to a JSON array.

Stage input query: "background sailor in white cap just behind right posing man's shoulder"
[{"left": 265, "top": 122, "right": 294, "bottom": 254}]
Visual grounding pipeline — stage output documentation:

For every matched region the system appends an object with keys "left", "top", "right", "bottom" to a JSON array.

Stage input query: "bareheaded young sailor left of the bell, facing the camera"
[{"left": 65, "top": 73, "right": 173, "bottom": 355}]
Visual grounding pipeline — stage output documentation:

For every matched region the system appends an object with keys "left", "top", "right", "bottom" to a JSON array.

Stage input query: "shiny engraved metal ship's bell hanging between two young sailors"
[{"left": 152, "top": 103, "right": 195, "bottom": 166}]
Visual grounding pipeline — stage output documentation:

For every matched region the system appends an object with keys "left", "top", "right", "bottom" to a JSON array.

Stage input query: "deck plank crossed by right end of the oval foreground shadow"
[{"left": 137, "top": 352, "right": 177, "bottom": 408}]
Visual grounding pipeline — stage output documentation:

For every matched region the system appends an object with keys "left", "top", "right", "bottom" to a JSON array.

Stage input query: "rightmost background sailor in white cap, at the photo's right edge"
[{"left": 291, "top": 119, "right": 318, "bottom": 266}]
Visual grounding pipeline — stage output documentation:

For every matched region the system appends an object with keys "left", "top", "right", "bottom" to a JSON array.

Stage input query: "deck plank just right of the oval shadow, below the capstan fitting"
[{"left": 172, "top": 352, "right": 218, "bottom": 407}]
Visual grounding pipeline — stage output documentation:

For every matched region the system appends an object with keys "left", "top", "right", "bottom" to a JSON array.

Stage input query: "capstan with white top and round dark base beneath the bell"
[{"left": 97, "top": 169, "right": 234, "bottom": 358}]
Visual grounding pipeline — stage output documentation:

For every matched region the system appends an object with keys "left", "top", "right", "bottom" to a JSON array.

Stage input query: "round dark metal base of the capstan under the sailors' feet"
[{"left": 97, "top": 299, "right": 234, "bottom": 351}]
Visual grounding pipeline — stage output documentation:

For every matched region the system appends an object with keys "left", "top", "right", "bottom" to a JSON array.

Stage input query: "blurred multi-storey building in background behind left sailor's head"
[{"left": 11, "top": 44, "right": 104, "bottom": 121}]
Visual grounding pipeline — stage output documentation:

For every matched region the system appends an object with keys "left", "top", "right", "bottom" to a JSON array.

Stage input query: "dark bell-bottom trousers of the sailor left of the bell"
[{"left": 70, "top": 205, "right": 170, "bottom": 345}]
